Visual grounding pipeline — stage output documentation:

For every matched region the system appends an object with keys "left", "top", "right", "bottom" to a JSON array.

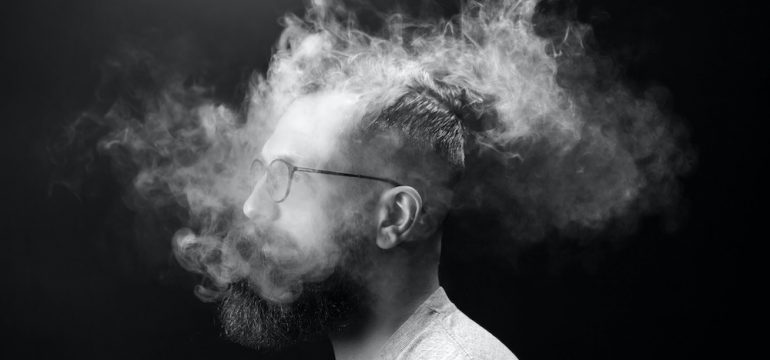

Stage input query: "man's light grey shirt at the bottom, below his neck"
[{"left": 379, "top": 287, "right": 516, "bottom": 360}]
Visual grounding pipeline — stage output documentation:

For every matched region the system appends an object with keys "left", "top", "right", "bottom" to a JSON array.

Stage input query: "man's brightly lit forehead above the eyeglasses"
[{"left": 262, "top": 93, "right": 361, "bottom": 166}]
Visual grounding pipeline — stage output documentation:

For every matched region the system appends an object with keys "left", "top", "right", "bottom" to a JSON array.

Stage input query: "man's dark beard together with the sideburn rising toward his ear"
[{"left": 220, "top": 200, "right": 371, "bottom": 349}]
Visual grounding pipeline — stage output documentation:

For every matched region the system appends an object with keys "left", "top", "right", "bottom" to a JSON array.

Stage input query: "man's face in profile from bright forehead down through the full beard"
[{"left": 222, "top": 94, "right": 368, "bottom": 347}]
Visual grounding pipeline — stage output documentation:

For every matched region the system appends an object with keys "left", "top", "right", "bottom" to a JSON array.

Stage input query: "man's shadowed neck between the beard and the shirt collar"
[{"left": 330, "top": 242, "right": 439, "bottom": 360}]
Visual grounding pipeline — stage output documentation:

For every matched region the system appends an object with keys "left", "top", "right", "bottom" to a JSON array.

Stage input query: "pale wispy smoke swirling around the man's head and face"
[{"left": 54, "top": 0, "right": 691, "bottom": 302}]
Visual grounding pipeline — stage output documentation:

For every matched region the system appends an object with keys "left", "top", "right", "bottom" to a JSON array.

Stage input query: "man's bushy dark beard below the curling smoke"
[{"left": 220, "top": 269, "right": 366, "bottom": 349}]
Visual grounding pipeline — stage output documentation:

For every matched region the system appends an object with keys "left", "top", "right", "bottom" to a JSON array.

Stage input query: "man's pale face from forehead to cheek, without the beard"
[{"left": 243, "top": 90, "right": 354, "bottom": 278}]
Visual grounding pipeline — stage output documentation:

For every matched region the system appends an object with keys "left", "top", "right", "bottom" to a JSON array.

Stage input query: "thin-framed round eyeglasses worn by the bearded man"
[{"left": 251, "top": 159, "right": 401, "bottom": 203}]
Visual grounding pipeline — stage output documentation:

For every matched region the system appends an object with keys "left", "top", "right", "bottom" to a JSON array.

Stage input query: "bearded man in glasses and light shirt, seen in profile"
[{"left": 223, "top": 72, "right": 515, "bottom": 360}]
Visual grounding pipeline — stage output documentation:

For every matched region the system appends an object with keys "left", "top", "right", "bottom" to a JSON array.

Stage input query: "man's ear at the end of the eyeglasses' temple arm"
[{"left": 377, "top": 186, "right": 422, "bottom": 250}]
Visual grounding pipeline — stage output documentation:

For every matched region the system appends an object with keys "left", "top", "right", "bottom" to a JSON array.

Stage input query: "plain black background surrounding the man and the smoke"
[{"left": 0, "top": 0, "right": 768, "bottom": 359}]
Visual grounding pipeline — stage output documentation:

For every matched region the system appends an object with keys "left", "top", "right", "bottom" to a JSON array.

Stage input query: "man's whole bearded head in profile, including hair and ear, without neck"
[{"left": 222, "top": 78, "right": 488, "bottom": 347}]
